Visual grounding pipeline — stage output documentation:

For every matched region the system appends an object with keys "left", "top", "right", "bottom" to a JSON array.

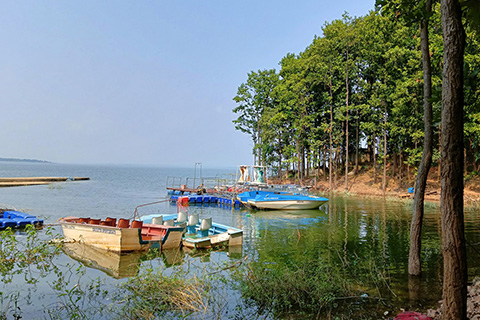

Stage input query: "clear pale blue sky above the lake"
[{"left": 0, "top": 0, "right": 375, "bottom": 167}]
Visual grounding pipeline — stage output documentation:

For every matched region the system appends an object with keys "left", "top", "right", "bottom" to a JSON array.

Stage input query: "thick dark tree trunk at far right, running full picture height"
[{"left": 440, "top": 0, "right": 467, "bottom": 320}]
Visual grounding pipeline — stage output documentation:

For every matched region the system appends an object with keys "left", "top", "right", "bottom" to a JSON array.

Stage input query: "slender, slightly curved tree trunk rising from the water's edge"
[{"left": 408, "top": 0, "right": 433, "bottom": 276}]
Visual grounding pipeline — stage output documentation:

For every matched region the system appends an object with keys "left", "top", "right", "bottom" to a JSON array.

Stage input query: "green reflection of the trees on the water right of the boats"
[{"left": 242, "top": 197, "right": 480, "bottom": 316}]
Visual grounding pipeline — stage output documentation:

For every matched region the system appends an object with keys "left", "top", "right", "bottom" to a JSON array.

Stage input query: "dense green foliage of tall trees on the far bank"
[{"left": 234, "top": 0, "right": 480, "bottom": 182}]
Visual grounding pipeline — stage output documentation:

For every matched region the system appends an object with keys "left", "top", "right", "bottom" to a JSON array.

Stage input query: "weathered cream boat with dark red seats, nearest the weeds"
[{"left": 59, "top": 217, "right": 183, "bottom": 252}]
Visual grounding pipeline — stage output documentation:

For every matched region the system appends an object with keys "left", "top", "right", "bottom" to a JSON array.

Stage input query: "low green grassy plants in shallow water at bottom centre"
[{"left": 234, "top": 250, "right": 389, "bottom": 316}]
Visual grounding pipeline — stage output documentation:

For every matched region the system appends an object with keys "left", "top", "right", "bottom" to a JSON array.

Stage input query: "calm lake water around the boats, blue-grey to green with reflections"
[{"left": 0, "top": 162, "right": 480, "bottom": 319}]
